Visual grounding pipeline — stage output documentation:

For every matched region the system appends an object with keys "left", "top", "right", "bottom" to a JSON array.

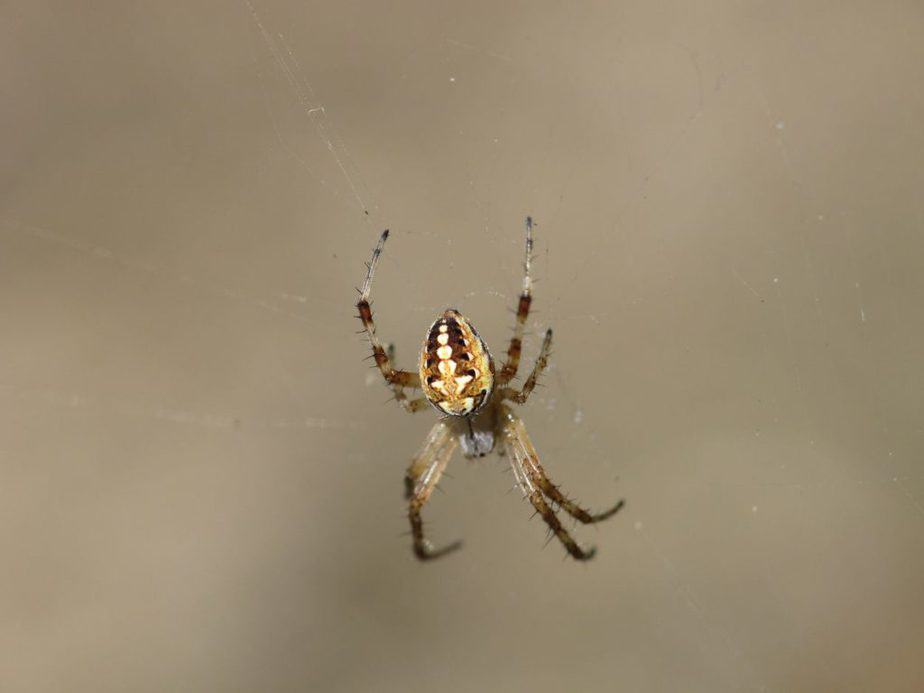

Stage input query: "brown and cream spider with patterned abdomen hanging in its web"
[{"left": 356, "top": 217, "right": 624, "bottom": 561}]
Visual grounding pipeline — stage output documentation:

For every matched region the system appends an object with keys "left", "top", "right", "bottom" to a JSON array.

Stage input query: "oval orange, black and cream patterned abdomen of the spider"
[{"left": 420, "top": 309, "right": 494, "bottom": 416}]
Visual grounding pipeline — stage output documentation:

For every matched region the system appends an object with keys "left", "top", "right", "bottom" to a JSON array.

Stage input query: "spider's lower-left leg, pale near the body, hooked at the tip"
[{"left": 404, "top": 421, "right": 462, "bottom": 561}]
